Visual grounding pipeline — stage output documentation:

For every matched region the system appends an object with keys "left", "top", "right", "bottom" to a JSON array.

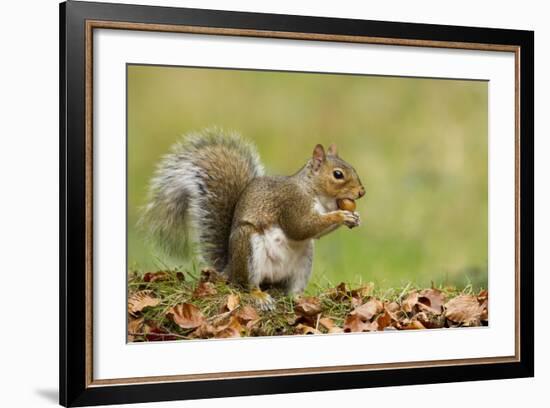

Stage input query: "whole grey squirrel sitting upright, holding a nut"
[{"left": 140, "top": 129, "right": 365, "bottom": 307}]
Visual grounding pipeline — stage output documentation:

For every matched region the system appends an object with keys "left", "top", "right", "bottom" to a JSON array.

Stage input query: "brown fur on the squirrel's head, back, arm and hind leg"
[{"left": 225, "top": 145, "right": 364, "bottom": 284}]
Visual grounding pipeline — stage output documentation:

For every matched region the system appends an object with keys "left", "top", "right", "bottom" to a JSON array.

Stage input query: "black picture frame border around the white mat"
[{"left": 59, "top": 1, "right": 534, "bottom": 406}]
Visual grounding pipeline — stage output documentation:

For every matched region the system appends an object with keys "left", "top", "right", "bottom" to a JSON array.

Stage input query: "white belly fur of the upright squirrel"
[{"left": 250, "top": 226, "right": 313, "bottom": 285}]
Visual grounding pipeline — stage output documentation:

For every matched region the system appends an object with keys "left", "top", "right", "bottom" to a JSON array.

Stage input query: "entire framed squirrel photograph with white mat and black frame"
[{"left": 60, "top": 1, "right": 534, "bottom": 406}]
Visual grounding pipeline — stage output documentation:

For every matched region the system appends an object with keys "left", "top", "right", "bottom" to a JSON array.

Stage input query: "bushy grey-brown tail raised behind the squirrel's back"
[{"left": 140, "top": 129, "right": 263, "bottom": 271}]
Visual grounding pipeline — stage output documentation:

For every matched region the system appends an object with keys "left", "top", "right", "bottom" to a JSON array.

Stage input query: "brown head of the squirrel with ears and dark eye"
[{"left": 310, "top": 144, "right": 365, "bottom": 200}]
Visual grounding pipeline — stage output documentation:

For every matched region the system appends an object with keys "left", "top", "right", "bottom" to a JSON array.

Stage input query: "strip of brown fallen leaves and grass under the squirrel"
[{"left": 128, "top": 269, "right": 489, "bottom": 342}]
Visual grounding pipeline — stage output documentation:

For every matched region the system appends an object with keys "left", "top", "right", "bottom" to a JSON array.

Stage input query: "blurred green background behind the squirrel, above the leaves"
[{"left": 127, "top": 65, "right": 488, "bottom": 288}]
